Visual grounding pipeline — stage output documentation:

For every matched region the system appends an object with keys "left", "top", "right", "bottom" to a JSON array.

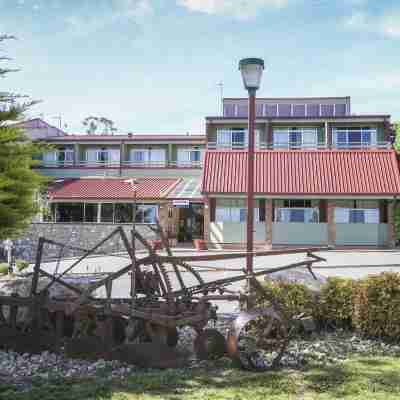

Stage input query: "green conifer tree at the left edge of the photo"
[{"left": 0, "top": 35, "right": 45, "bottom": 240}]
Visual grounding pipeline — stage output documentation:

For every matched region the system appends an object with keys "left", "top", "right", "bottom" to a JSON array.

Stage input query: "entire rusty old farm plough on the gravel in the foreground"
[{"left": 0, "top": 224, "right": 324, "bottom": 369}]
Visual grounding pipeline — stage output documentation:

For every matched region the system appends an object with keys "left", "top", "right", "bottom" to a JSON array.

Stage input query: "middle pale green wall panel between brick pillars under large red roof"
[{"left": 272, "top": 222, "right": 328, "bottom": 245}]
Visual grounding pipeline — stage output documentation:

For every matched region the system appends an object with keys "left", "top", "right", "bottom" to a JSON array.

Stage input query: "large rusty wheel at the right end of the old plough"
[{"left": 227, "top": 307, "right": 288, "bottom": 371}]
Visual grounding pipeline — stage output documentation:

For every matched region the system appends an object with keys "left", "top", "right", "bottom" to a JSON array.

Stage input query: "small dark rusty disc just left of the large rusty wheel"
[{"left": 194, "top": 329, "right": 226, "bottom": 360}]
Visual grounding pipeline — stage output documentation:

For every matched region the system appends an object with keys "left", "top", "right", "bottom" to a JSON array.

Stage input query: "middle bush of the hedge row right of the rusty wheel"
[{"left": 314, "top": 277, "right": 355, "bottom": 329}]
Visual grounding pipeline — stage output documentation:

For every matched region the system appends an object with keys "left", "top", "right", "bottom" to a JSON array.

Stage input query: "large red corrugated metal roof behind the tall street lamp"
[{"left": 202, "top": 150, "right": 400, "bottom": 196}]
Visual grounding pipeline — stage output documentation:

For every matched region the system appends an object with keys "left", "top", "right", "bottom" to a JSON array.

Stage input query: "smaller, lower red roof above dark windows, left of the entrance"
[{"left": 49, "top": 178, "right": 180, "bottom": 201}]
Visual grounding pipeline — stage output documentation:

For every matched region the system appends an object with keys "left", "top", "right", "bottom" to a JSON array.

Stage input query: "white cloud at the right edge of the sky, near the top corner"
[{"left": 344, "top": 10, "right": 400, "bottom": 39}]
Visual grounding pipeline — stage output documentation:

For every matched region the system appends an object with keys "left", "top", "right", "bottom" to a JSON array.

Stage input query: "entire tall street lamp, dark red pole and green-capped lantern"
[{"left": 239, "top": 58, "right": 264, "bottom": 274}]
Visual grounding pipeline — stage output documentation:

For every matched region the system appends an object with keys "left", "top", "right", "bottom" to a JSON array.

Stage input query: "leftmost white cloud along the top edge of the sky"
[{"left": 65, "top": 0, "right": 153, "bottom": 36}]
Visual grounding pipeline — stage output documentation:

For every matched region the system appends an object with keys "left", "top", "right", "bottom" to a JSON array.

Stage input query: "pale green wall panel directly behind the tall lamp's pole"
[{"left": 209, "top": 222, "right": 265, "bottom": 244}]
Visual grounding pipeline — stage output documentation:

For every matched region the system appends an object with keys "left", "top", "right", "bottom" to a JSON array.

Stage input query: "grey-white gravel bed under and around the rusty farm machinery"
[{"left": 0, "top": 314, "right": 400, "bottom": 390}]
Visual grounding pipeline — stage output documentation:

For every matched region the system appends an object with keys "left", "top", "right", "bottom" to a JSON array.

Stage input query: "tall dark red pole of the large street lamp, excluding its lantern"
[{"left": 246, "top": 89, "right": 256, "bottom": 274}]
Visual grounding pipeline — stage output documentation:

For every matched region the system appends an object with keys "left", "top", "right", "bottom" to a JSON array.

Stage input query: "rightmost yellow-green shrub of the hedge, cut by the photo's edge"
[{"left": 353, "top": 272, "right": 400, "bottom": 339}]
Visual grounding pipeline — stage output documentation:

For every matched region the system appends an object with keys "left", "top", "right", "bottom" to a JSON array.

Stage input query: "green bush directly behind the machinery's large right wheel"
[{"left": 256, "top": 280, "right": 315, "bottom": 317}]
